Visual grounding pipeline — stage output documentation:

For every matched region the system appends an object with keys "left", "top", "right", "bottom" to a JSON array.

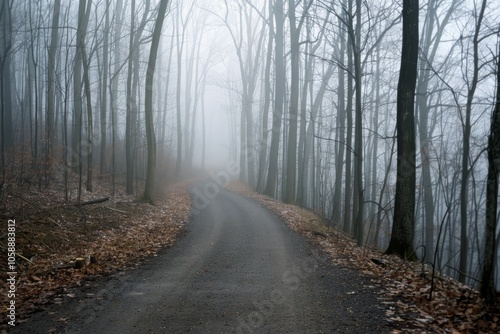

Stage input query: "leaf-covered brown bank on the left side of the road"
[{"left": 0, "top": 176, "right": 191, "bottom": 328}]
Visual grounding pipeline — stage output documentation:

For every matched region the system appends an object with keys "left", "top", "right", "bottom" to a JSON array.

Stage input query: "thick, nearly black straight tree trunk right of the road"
[{"left": 386, "top": 0, "right": 419, "bottom": 259}]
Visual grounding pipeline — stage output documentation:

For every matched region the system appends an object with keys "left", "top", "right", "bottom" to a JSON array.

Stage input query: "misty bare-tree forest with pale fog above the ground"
[{"left": 0, "top": 0, "right": 500, "bottom": 324}]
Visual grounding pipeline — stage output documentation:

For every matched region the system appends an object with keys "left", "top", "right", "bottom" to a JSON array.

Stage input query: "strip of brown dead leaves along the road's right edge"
[{"left": 228, "top": 182, "right": 500, "bottom": 333}]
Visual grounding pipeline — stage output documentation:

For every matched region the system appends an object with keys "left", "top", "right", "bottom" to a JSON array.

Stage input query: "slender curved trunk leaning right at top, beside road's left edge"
[{"left": 141, "top": 0, "right": 168, "bottom": 204}]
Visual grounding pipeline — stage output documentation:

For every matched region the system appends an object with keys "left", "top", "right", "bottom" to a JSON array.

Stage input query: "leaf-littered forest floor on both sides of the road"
[{"left": 0, "top": 176, "right": 500, "bottom": 333}]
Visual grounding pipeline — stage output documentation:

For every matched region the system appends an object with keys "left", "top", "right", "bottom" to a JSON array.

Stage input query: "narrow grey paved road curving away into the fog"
[{"left": 12, "top": 185, "right": 389, "bottom": 333}]
